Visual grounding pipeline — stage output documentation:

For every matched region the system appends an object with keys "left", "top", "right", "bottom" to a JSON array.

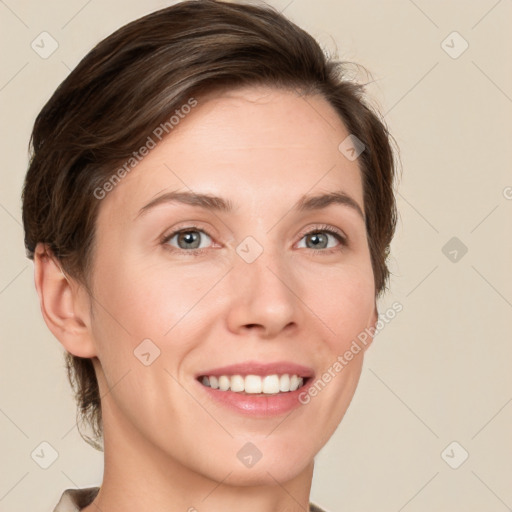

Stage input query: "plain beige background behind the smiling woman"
[{"left": 0, "top": 0, "right": 512, "bottom": 512}]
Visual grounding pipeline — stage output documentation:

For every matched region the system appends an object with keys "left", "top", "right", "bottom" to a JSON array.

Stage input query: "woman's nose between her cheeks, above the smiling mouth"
[{"left": 227, "top": 251, "right": 301, "bottom": 338}]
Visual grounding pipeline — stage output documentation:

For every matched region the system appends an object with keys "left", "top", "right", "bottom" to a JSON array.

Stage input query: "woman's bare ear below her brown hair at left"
[{"left": 34, "top": 243, "right": 96, "bottom": 358}]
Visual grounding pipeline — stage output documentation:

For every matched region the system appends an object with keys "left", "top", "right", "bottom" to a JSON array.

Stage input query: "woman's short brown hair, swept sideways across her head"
[{"left": 23, "top": 0, "right": 397, "bottom": 449}]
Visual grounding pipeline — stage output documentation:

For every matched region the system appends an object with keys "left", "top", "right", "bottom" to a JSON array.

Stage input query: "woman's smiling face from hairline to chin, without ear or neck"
[{"left": 86, "top": 87, "right": 377, "bottom": 485}]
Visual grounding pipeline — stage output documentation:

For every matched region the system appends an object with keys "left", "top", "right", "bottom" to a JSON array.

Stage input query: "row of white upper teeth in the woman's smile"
[{"left": 201, "top": 373, "right": 304, "bottom": 395}]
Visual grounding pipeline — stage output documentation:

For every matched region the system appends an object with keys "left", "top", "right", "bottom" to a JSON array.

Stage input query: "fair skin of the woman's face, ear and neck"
[{"left": 35, "top": 87, "right": 377, "bottom": 512}]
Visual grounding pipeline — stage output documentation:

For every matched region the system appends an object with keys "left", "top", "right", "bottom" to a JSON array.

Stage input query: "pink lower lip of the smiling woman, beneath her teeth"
[{"left": 196, "top": 377, "right": 313, "bottom": 418}]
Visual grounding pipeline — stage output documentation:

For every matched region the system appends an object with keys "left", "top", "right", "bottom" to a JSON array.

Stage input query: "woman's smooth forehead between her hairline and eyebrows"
[{"left": 102, "top": 87, "right": 363, "bottom": 217}]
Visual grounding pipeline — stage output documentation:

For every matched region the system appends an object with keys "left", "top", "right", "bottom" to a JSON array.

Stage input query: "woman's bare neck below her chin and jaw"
[{"left": 83, "top": 400, "right": 314, "bottom": 512}]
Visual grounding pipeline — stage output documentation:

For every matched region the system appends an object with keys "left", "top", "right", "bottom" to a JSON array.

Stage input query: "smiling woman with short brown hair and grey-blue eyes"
[{"left": 23, "top": 0, "right": 396, "bottom": 512}]
